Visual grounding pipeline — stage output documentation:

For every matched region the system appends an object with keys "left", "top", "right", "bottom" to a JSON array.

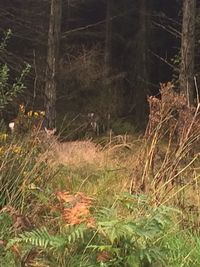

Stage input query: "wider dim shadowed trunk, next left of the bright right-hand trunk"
[{"left": 134, "top": 0, "right": 148, "bottom": 127}]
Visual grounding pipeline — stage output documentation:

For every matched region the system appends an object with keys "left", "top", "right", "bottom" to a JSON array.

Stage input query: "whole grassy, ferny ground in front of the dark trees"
[{"left": 0, "top": 132, "right": 200, "bottom": 267}]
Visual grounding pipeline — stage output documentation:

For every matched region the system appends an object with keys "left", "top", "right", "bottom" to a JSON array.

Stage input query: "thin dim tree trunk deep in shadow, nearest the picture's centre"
[{"left": 104, "top": 0, "right": 112, "bottom": 82}]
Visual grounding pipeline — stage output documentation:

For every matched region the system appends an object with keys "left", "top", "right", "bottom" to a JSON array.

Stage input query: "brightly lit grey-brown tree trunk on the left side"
[{"left": 45, "top": 0, "right": 62, "bottom": 129}]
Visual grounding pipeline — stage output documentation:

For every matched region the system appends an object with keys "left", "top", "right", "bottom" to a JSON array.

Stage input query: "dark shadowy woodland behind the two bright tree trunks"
[{"left": 0, "top": 0, "right": 199, "bottom": 134}]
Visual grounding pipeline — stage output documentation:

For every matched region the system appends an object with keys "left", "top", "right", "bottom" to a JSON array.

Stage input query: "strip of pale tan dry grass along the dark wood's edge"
[{"left": 41, "top": 132, "right": 141, "bottom": 169}]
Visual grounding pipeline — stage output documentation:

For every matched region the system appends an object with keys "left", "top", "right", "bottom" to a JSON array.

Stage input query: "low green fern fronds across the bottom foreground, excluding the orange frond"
[{"left": 7, "top": 195, "right": 180, "bottom": 267}]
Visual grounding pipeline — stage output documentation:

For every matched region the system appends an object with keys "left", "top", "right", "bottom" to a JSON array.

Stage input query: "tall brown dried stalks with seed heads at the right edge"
[{"left": 131, "top": 83, "right": 200, "bottom": 220}]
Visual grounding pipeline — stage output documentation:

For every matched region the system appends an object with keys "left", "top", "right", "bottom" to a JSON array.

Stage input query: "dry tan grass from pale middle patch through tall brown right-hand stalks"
[{"left": 4, "top": 84, "right": 200, "bottom": 228}]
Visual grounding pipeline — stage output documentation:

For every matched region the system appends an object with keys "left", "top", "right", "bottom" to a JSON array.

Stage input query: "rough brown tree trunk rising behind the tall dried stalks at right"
[{"left": 179, "top": 0, "right": 196, "bottom": 104}]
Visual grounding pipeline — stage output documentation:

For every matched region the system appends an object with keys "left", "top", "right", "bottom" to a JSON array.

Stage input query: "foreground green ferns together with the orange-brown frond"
[{"left": 5, "top": 192, "right": 179, "bottom": 267}]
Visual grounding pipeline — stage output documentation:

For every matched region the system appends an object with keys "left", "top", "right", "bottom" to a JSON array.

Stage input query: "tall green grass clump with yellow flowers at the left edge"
[{"left": 0, "top": 136, "right": 57, "bottom": 209}]
